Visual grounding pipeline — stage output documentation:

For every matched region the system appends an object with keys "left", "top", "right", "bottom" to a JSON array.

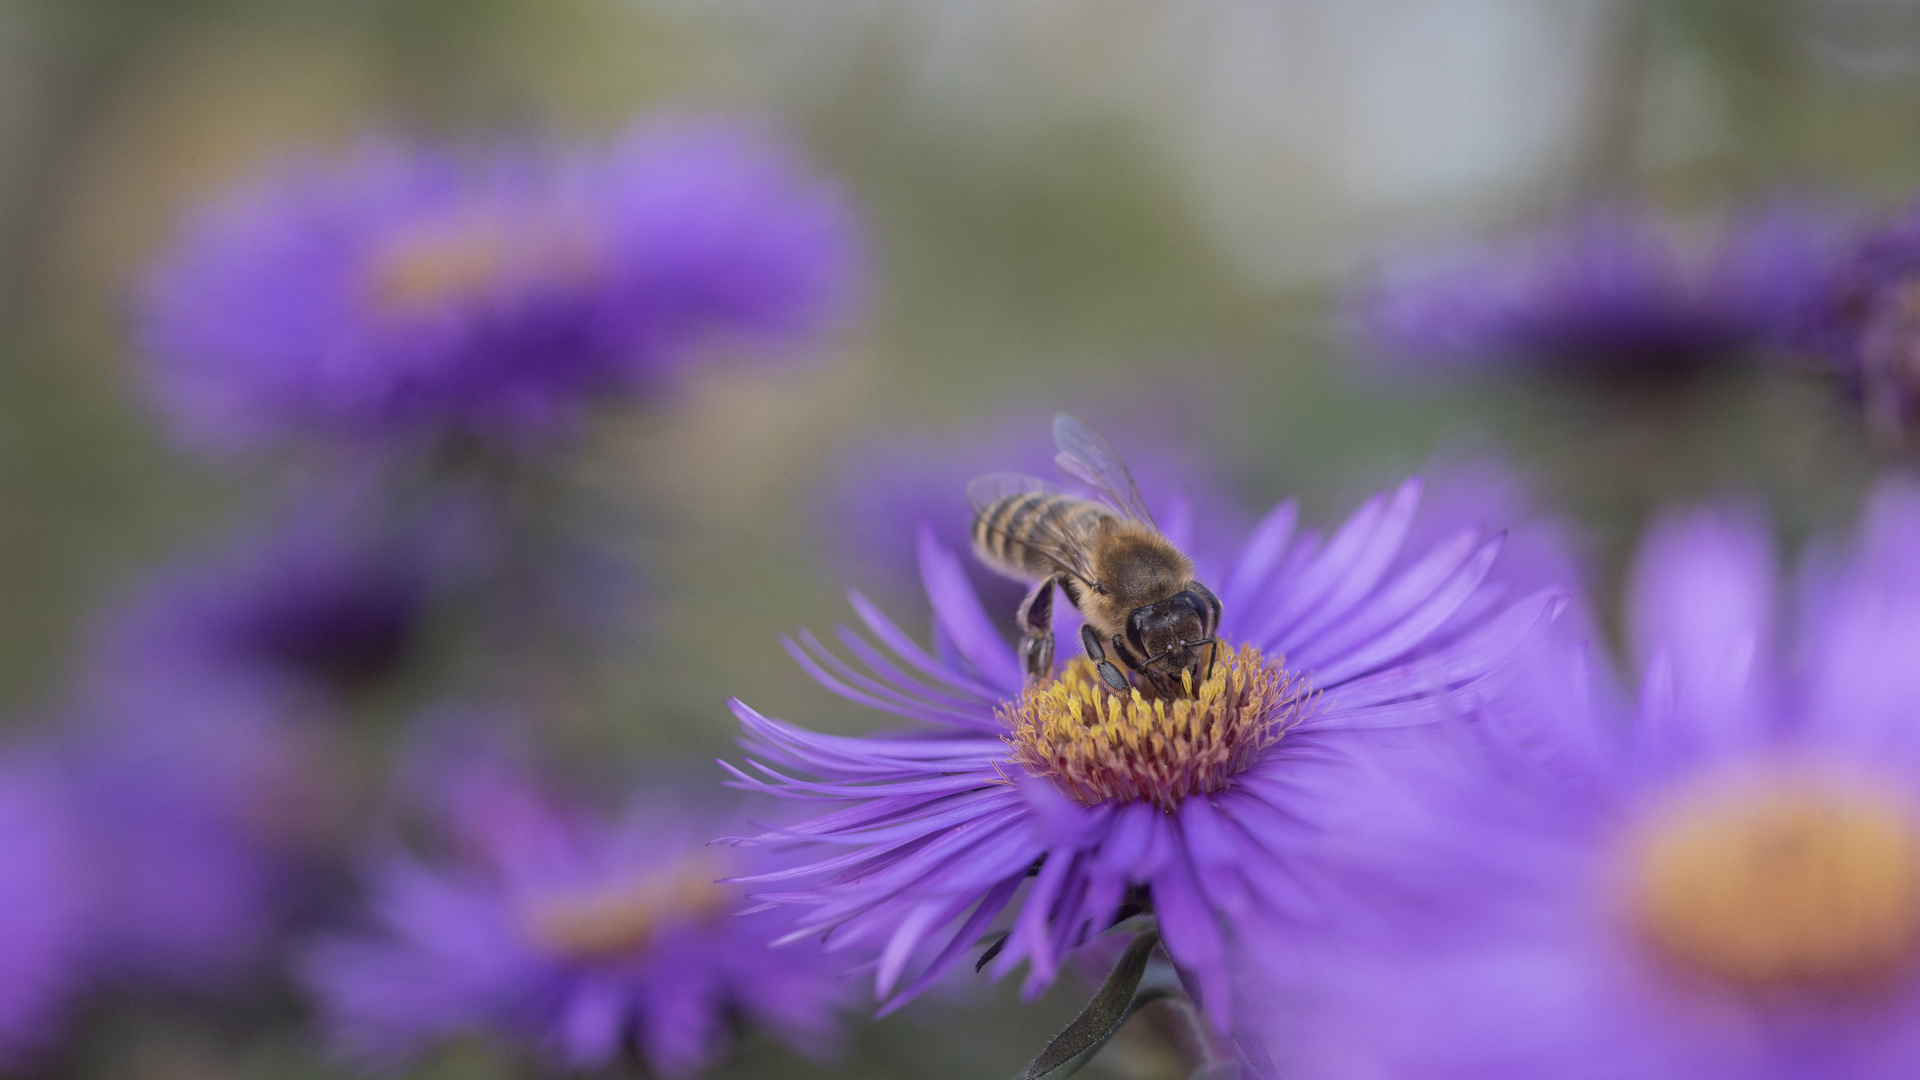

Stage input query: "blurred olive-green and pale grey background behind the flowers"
[{"left": 0, "top": 0, "right": 1920, "bottom": 1078}]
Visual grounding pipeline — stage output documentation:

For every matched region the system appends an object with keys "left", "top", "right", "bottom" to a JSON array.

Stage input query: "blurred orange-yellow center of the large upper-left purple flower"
[{"left": 367, "top": 209, "right": 597, "bottom": 311}]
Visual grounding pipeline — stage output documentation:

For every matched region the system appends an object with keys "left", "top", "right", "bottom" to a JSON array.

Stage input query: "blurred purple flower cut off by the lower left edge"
[{"left": 0, "top": 746, "right": 90, "bottom": 1072}]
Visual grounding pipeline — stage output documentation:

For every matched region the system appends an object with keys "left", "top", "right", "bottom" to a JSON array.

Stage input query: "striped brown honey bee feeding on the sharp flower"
[{"left": 968, "top": 413, "right": 1219, "bottom": 698}]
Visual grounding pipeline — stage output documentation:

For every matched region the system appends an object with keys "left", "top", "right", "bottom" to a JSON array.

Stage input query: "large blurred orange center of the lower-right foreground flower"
[{"left": 1634, "top": 776, "right": 1920, "bottom": 990}]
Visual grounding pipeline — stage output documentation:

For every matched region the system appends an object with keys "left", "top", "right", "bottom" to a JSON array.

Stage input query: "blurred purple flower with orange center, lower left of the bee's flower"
[{"left": 305, "top": 753, "right": 847, "bottom": 1076}]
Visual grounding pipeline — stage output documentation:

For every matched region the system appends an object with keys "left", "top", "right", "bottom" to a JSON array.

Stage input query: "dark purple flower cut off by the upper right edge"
[{"left": 1799, "top": 209, "right": 1920, "bottom": 444}]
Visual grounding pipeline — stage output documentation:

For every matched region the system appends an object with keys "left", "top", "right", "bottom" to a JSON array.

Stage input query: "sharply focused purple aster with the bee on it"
[{"left": 732, "top": 455, "right": 1551, "bottom": 1024}]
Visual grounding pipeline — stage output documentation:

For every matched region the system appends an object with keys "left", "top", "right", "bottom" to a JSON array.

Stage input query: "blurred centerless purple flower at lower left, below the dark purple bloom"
[{"left": 67, "top": 680, "right": 342, "bottom": 992}]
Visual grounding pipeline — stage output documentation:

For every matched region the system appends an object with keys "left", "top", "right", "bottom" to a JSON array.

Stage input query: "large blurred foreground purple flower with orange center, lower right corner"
[{"left": 1271, "top": 484, "right": 1920, "bottom": 1080}]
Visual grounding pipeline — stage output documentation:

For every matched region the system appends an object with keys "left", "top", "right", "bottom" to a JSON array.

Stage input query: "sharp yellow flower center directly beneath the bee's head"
[{"left": 1000, "top": 646, "right": 1313, "bottom": 811}]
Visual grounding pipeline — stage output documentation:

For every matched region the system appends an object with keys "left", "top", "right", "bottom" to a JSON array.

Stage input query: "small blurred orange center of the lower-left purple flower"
[{"left": 520, "top": 859, "right": 733, "bottom": 959}]
